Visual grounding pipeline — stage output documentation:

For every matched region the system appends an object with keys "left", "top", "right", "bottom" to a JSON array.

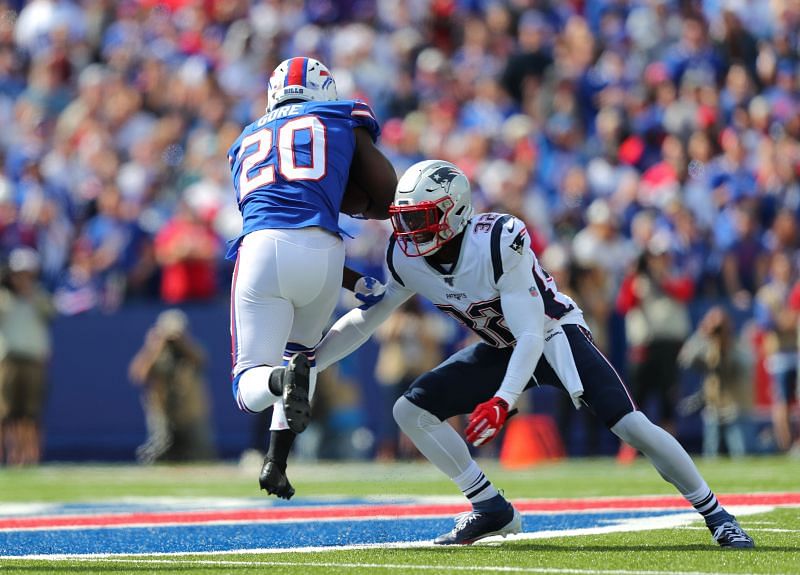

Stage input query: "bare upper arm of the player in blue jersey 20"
[{"left": 350, "top": 128, "right": 397, "bottom": 220}]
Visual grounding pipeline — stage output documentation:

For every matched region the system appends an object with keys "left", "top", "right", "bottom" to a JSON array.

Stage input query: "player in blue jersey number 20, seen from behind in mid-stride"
[{"left": 228, "top": 58, "right": 397, "bottom": 499}]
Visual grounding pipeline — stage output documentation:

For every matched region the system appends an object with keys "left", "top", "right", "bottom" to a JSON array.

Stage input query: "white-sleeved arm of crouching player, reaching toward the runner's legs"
[{"left": 317, "top": 280, "right": 414, "bottom": 371}]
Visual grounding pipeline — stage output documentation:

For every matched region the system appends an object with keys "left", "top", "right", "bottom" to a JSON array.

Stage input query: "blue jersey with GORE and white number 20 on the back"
[{"left": 222, "top": 100, "right": 380, "bottom": 257}]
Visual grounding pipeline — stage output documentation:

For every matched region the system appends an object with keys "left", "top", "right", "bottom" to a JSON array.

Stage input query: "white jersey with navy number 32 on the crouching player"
[{"left": 386, "top": 213, "right": 585, "bottom": 347}]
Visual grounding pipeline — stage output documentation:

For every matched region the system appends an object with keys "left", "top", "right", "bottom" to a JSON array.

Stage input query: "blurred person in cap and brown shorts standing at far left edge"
[{"left": 0, "top": 247, "right": 54, "bottom": 465}]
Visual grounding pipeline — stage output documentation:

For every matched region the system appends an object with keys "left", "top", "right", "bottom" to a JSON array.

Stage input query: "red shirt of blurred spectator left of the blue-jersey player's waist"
[{"left": 155, "top": 218, "right": 217, "bottom": 304}]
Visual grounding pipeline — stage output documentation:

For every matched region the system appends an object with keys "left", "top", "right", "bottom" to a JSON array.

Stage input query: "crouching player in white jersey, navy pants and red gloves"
[{"left": 317, "top": 160, "right": 753, "bottom": 547}]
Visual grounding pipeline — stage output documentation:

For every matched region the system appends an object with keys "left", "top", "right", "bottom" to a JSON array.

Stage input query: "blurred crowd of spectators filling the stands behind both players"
[{"left": 0, "top": 0, "right": 800, "bottom": 462}]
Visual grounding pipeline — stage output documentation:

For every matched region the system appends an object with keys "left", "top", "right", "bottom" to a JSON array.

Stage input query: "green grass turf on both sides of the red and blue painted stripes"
[{"left": 0, "top": 458, "right": 800, "bottom": 575}]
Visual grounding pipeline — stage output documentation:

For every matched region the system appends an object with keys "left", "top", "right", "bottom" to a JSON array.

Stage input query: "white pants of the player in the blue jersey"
[{"left": 231, "top": 227, "right": 344, "bottom": 412}]
